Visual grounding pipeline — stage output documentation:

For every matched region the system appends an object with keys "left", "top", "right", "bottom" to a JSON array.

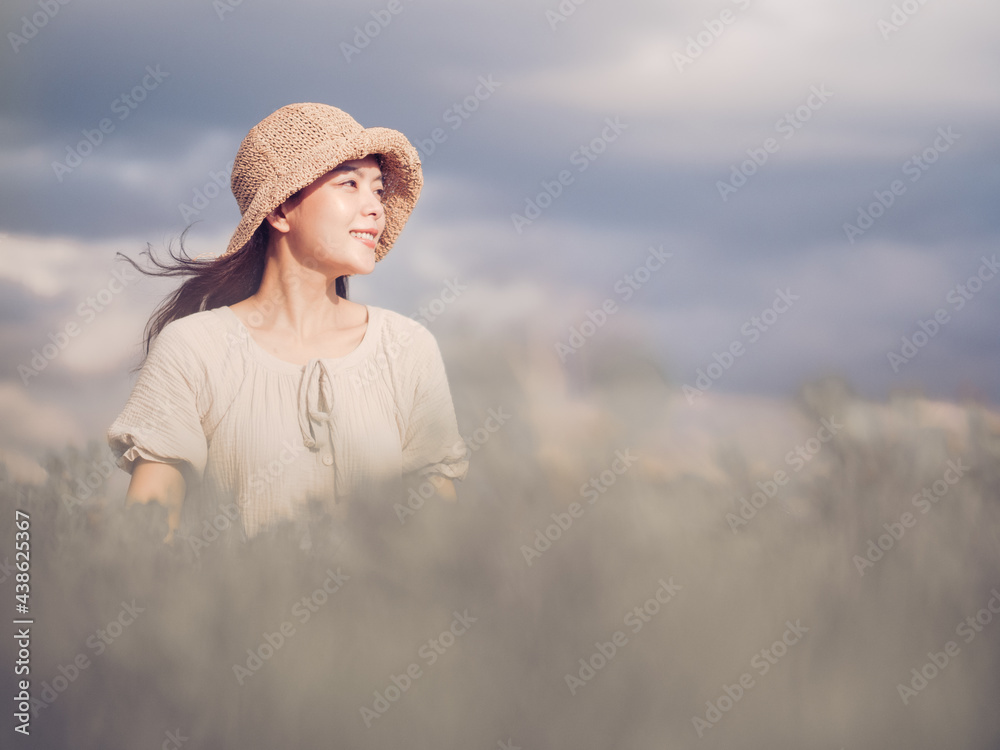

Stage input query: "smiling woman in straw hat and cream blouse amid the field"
[{"left": 108, "top": 104, "right": 468, "bottom": 540}]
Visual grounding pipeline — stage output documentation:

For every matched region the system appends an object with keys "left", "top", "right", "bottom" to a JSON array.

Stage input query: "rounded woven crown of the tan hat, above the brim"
[{"left": 230, "top": 102, "right": 364, "bottom": 214}]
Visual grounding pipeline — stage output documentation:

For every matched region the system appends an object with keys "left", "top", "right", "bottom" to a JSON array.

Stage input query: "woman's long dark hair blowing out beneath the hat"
[{"left": 117, "top": 221, "right": 347, "bottom": 373}]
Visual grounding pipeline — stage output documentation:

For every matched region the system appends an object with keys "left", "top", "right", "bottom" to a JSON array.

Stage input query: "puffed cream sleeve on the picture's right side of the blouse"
[{"left": 403, "top": 329, "right": 469, "bottom": 480}]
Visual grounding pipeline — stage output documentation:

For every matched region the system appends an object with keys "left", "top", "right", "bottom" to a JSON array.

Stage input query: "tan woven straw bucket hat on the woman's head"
[{"left": 219, "top": 104, "right": 423, "bottom": 261}]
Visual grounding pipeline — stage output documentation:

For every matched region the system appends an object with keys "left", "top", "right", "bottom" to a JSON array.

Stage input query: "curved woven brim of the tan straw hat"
[{"left": 220, "top": 127, "right": 423, "bottom": 262}]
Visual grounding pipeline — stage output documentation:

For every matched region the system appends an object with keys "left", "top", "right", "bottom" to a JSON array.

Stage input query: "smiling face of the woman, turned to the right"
[{"left": 283, "top": 156, "right": 385, "bottom": 276}]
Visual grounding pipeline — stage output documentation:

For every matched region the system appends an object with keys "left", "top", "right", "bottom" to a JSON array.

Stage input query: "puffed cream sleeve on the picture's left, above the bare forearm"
[{"left": 107, "top": 321, "right": 208, "bottom": 481}]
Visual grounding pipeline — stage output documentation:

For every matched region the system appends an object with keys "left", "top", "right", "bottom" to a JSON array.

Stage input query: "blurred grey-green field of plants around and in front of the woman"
[{"left": 0, "top": 336, "right": 1000, "bottom": 750}]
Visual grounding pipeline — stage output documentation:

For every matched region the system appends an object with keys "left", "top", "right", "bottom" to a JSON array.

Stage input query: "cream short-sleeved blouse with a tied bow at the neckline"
[{"left": 107, "top": 305, "right": 469, "bottom": 539}]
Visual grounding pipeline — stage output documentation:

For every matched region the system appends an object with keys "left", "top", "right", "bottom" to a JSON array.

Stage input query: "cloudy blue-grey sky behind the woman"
[{"left": 0, "top": 0, "right": 1000, "bottom": 478}]
